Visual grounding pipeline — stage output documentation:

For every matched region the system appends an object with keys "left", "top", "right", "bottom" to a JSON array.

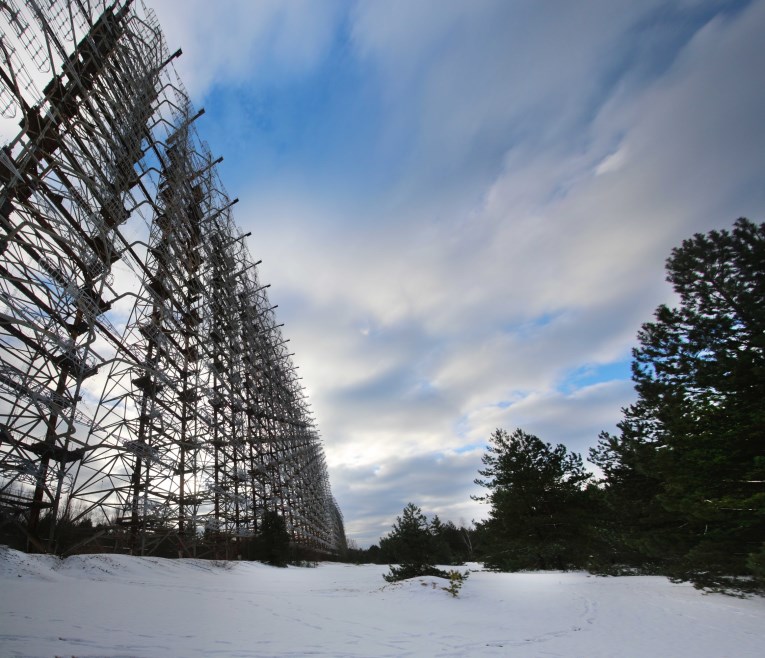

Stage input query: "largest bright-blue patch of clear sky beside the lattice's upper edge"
[{"left": 201, "top": 23, "right": 388, "bottom": 206}]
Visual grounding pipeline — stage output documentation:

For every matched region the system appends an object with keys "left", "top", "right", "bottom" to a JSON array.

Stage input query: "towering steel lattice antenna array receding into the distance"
[{"left": 0, "top": 0, "right": 345, "bottom": 555}]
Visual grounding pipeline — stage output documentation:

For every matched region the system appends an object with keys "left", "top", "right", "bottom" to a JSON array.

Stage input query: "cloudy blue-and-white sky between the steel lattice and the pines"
[{"left": 143, "top": 0, "right": 765, "bottom": 547}]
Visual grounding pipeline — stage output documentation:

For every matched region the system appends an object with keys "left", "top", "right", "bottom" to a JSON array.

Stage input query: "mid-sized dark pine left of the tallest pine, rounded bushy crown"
[{"left": 475, "top": 429, "right": 591, "bottom": 570}]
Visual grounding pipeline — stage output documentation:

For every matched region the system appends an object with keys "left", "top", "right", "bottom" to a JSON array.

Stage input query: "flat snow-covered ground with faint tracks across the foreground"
[{"left": 0, "top": 548, "right": 765, "bottom": 658}]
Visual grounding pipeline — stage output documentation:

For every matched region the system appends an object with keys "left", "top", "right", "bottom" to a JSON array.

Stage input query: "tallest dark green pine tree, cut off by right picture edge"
[{"left": 592, "top": 219, "right": 765, "bottom": 589}]
